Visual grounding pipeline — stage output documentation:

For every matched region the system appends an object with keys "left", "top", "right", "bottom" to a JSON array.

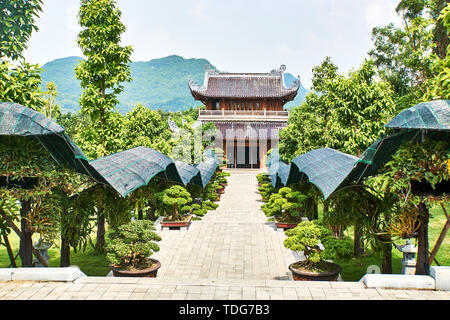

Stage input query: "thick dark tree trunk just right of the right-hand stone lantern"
[{"left": 416, "top": 202, "right": 430, "bottom": 275}]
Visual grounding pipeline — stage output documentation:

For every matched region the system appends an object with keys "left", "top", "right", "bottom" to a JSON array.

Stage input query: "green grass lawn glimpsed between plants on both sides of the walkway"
[{"left": 0, "top": 205, "right": 450, "bottom": 281}]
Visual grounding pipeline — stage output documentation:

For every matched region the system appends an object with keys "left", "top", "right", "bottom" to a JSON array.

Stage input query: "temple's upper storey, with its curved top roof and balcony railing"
[{"left": 188, "top": 65, "right": 300, "bottom": 121}]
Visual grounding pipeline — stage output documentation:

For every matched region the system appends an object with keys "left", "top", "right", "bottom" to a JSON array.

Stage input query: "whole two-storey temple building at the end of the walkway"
[{"left": 188, "top": 65, "right": 300, "bottom": 168}]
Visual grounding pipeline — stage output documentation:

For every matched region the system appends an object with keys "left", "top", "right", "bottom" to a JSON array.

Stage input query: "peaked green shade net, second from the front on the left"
[{"left": 89, "top": 147, "right": 183, "bottom": 197}]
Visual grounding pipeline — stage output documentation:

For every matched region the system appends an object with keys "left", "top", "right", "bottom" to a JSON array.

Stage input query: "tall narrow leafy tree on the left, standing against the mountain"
[{"left": 75, "top": 0, "right": 133, "bottom": 250}]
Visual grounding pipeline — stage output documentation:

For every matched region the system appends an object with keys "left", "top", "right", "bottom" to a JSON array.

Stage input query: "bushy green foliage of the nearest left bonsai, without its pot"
[{"left": 106, "top": 220, "right": 161, "bottom": 269}]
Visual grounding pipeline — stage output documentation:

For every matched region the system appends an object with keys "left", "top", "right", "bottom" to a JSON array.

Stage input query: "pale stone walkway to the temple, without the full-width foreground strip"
[{"left": 154, "top": 171, "right": 298, "bottom": 280}]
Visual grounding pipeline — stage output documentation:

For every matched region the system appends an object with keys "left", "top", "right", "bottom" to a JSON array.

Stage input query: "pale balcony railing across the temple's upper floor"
[{"left": 198, "top": 109, "right": 289, "bottom": 122}]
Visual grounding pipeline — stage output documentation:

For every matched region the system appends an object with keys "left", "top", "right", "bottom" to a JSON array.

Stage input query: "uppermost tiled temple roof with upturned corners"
[{"left": 188, "top": 65, "right": 300, "bottom": 101}]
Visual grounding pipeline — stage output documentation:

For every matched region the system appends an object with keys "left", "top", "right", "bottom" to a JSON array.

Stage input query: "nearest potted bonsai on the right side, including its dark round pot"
[{"left": 284, "top": 221, "right": 341, "bottom": 281}]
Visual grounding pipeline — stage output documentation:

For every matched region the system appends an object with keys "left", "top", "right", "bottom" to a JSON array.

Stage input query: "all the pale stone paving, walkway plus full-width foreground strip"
[{"left": 0, "top": 171, "right": 450, "bottom": 300}]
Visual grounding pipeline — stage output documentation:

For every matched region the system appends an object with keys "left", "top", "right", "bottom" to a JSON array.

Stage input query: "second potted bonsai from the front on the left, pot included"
[{"left": 159, "top": 185, "right": 192, "bottom": 228}]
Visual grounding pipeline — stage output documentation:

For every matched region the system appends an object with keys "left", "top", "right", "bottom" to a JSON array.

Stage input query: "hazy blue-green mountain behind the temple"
[{"left": 42, "top": 55, "right": 308, "bottom": 114}]
